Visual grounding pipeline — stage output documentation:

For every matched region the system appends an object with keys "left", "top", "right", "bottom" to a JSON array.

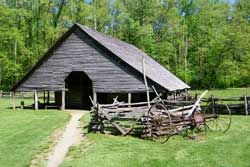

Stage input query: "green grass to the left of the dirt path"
[{"left": 0, "top": 99, "right": 70, "bottom": 167}]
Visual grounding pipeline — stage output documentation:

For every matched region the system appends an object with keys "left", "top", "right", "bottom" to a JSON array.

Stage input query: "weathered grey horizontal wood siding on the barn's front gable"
[{"left": 16, "top": 28, "right": 158, "bottom": 92}]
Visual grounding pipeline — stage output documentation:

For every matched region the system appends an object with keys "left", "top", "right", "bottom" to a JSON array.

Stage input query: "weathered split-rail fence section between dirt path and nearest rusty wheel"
[{"left": 89, "top": 102, "right": 153, "bottom": 135}]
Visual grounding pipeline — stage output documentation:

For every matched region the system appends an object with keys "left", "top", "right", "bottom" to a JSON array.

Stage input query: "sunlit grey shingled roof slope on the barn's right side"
[{"left": 76, "top": 24, "right": 190, "bottom": 91}]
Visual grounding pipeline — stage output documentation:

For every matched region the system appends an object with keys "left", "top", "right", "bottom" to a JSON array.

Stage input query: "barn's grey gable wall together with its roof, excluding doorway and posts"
[{"left": 12, "top": 24, "right": 190, "bottom": 93}]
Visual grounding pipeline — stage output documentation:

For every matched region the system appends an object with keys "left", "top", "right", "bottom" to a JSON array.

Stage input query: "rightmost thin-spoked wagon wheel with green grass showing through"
[{"left": 204, "top": 103, "right": 231, "bottom": 133}]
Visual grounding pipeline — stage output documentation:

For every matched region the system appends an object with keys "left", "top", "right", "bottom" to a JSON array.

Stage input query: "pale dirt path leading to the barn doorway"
[{"left": 47, "top": 110, "right": 85, "bottom": 167}]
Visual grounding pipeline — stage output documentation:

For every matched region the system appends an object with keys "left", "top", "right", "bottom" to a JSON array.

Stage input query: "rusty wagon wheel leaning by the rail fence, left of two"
[{"left": 147, "top": 103, "right": 175, "bottom": 143}]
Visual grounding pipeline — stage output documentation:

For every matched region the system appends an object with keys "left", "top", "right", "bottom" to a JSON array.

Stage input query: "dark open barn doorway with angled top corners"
[{"left": 65, "top": 71, "right": 92, "bottom": 109}]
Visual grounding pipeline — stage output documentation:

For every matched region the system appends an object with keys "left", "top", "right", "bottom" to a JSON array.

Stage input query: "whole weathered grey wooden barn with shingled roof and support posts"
[{"left": 12, "top": 24, "right": 190, "bottom": 109}]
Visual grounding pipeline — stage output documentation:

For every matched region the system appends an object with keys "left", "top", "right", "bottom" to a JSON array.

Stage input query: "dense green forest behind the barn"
[{"left": 0, "top": 0, "right": 250, "bottom": 90}]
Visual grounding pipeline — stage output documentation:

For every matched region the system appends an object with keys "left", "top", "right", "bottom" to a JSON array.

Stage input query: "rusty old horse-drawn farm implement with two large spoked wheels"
[{"left": 143, "top": 91, "right": 231, "bottom": 142}]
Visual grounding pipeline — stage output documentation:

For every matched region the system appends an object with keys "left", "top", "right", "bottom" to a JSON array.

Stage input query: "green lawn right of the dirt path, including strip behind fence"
[{"left": 61, "top": 88, "right": 250, "bottom": 167}]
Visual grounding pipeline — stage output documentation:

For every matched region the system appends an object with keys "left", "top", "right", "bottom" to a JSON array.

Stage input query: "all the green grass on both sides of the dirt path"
[{"left": 0, "top": 88, "right": 250, "bottom": 167}]
